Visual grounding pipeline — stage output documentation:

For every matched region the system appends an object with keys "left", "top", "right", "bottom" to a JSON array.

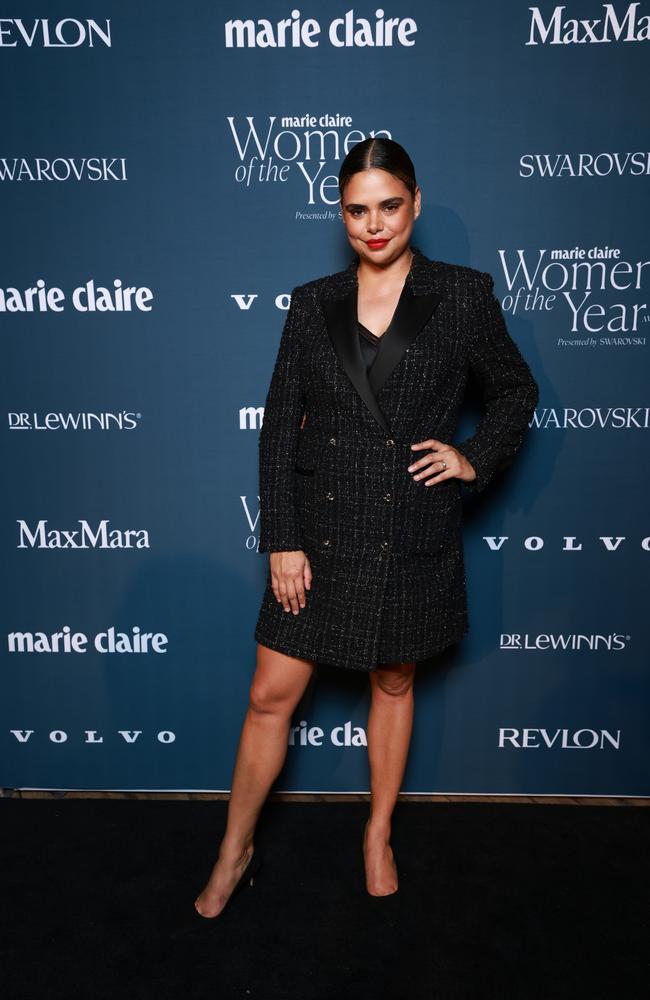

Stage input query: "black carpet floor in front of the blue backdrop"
[{"left": 0, "top": 799, "right": 650, "bottom": 1000}]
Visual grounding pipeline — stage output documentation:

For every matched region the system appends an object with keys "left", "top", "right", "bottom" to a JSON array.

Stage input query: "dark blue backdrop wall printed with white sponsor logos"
[{"left": 0, "top": 0, "right": 650, "bottom": 796}]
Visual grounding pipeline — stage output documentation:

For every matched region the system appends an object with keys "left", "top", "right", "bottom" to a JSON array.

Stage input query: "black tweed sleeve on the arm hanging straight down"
[{"left": 258, "top": 286, "right": 306, "bottom": 552}]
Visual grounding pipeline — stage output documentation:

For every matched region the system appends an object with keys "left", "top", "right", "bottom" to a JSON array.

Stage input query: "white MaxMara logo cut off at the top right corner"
[{"left": 526, "top": 3, "right": 650, "bottom": 45}]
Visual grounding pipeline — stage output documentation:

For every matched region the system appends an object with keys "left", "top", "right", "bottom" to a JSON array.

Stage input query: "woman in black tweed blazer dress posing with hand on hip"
[{"left": 195, "top": 139, "right": 538, "bottom": 917}]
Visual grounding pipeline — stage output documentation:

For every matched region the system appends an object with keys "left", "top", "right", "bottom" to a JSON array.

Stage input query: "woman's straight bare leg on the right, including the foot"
[{"left": 364, "top": 663, "right": 415, "bottom": 896}]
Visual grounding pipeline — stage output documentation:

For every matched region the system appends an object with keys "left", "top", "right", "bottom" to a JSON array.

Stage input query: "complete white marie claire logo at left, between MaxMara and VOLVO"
[{"left": 7, "top": 625, "right": 169, "bottom": 653}]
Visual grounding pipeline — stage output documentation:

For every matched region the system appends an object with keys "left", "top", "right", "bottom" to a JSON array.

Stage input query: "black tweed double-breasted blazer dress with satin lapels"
[{"left": 255, "top": 246, "right": 539, "bottom": 671}]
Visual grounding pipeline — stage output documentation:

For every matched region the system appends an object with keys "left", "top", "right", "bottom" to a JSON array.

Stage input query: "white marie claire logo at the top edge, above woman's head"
[{"left": 224, "top": 8, "right": 418, "bottom": 49}]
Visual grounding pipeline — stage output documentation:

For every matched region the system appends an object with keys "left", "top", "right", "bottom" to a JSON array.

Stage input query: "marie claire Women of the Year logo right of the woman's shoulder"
[{"left": 498, "top": 246, "right": 650, "bottom": 347}]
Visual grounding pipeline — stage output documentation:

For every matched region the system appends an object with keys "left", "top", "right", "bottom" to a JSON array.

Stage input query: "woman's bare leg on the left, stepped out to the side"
[{"left": 194, "top": 643, "right": 314, "bottom": 917}]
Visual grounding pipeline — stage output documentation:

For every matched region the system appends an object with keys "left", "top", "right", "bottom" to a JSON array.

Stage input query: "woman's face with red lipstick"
[{"left": 341, "top": 167, "right": 420, "bottom": 265}]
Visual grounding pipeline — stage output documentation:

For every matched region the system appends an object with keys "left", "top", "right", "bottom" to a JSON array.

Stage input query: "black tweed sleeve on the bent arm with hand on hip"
[{"left": 454, "top": 271, "right": 539, "bottom": 493}]
